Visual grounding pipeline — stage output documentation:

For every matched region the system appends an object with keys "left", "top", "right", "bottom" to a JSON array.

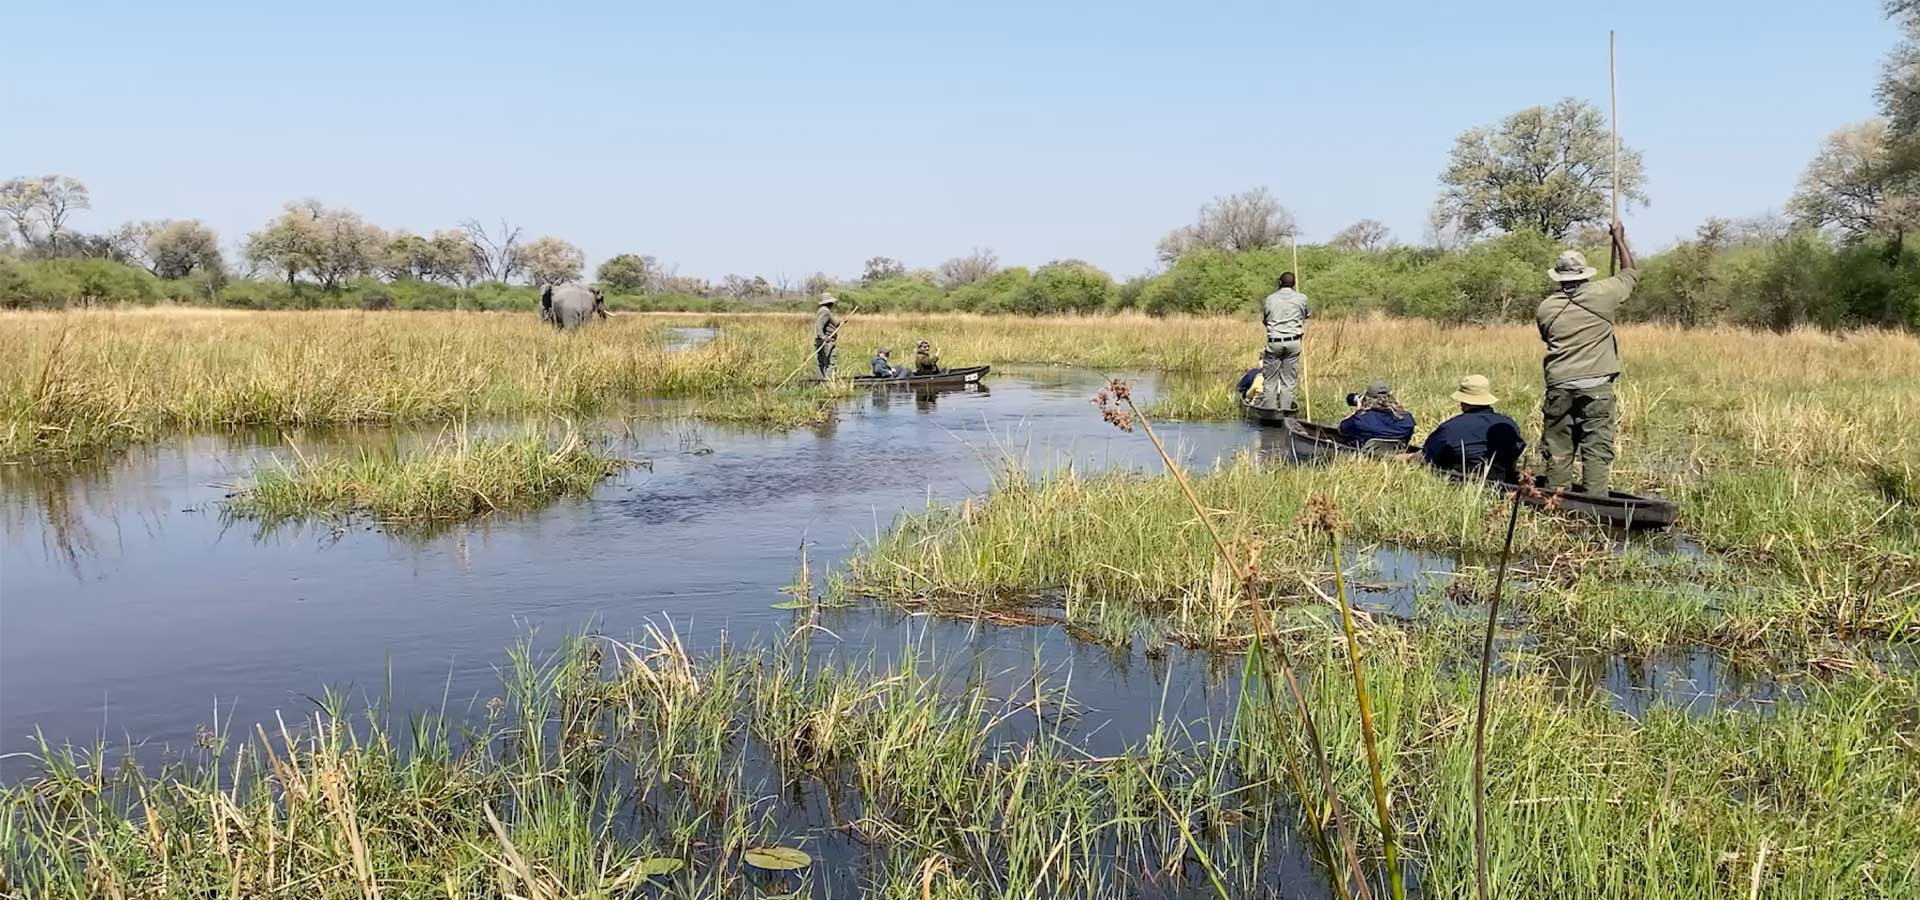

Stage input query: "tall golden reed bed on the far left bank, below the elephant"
[{"left": 0, "top": 311, "right": 848, "bottom": 459}]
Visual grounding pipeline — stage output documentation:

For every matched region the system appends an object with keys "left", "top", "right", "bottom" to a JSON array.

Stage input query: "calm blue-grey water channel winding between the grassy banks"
[{"left": 0, "top": 364, "right": 1766, "bottom": 777}]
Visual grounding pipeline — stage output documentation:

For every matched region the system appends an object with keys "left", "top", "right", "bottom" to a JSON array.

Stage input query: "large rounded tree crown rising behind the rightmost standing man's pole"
[{"left": 1440, "top": 98, "right": 1647, "bottom": 240}]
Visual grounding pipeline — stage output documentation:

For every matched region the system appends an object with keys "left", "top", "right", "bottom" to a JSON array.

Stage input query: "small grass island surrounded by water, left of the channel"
[{"left": 227, "top": 434, "right": 626, "bottom": 526}]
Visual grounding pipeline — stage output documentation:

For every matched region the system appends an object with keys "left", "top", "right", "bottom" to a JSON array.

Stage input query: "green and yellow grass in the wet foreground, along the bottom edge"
[{"left": 0, "top": 635, "right": 1920, "bottom": 900}]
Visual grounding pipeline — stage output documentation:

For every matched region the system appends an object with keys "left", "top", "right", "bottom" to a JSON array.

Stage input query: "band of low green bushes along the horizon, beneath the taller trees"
[{"left": 0, "top": 231, "right": 1920, "bottom": 330}]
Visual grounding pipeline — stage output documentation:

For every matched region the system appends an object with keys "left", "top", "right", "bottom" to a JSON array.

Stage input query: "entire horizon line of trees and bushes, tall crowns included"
[{"left": 11, "top": 0, "right": 1920, "bottom": 328}]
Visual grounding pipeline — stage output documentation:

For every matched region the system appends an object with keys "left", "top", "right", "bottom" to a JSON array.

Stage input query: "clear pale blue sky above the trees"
[{"left": 0, "top": 0, "right": 1897, "bottom": 278}]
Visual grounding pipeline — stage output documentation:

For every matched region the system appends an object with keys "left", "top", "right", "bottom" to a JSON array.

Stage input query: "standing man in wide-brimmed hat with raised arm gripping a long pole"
[{"left": 1534, "top": 223, "right": 1640, "bottom": 493}]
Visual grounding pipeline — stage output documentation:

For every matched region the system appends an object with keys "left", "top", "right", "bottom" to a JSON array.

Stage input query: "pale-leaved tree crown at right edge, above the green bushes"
[{"left": 1788, "top": 119, "right": 1920, "bottom": 242}]
